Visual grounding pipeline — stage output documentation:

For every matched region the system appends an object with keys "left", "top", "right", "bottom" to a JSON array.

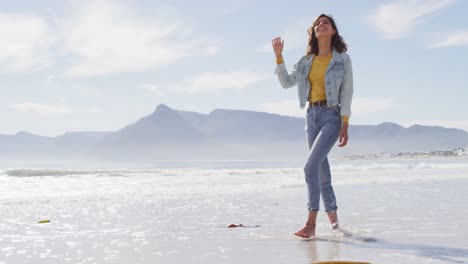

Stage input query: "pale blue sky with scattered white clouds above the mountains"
[{"left": 0, "top": 0, "right": 468, "bottom": 136}]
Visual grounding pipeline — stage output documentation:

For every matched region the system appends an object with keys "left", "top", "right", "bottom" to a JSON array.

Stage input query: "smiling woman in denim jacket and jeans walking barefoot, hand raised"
[{"left": 272, "top": 14, "right": 353, "bottom": 238}]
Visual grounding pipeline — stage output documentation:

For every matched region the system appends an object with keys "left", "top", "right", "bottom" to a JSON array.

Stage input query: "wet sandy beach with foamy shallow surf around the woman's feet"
[{"left": 0, "top": 159, "right": 468, "bottom": 264}]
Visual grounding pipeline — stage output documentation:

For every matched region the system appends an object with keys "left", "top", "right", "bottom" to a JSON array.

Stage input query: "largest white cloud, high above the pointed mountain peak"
[{"left": 60, "top": 1, "right": 219, "bottom": 76}]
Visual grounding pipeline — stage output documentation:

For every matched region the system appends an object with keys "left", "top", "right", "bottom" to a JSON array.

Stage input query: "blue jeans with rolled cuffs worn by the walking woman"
[{"left": 304, "top": 106, "right": 341, "bottom": 212}]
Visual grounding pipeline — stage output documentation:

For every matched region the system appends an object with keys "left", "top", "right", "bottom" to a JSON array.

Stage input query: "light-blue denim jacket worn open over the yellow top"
[{"left": 275, "top": 49, "right": 353, "bottom": 116}]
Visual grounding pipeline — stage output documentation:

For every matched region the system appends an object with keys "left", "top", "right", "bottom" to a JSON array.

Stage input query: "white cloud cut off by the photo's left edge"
[{"left": 0, "top": 13, "right": 56, "bottom": 72}]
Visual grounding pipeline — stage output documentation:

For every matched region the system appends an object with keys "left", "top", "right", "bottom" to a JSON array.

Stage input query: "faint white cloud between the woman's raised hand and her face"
[{"left": 257, "top": 17, "right": 313, "bottom": 52}]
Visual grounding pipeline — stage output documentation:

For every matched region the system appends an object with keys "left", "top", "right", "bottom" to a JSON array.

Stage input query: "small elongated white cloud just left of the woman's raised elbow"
[{"left": 188, "top": 71, "right": 268, "bottom": 93}]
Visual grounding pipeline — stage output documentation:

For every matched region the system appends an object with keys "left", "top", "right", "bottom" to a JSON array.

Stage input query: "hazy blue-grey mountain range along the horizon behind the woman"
[{"left": 0, "top": 104, "right": 468, "bottom": 161}]
